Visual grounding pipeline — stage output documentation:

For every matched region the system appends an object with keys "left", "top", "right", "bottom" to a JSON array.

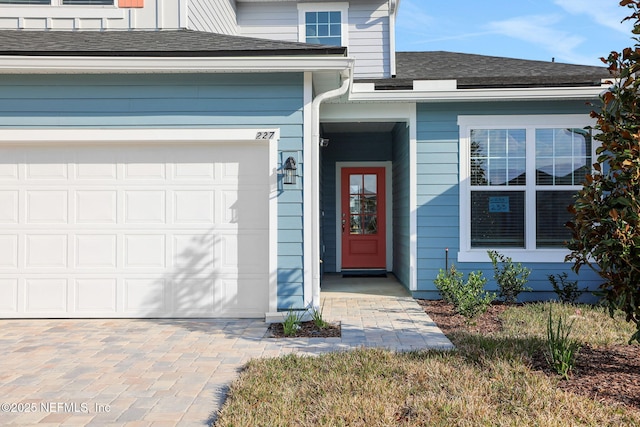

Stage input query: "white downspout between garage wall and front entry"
[{"left": 311, "top": 65, "right": 353, "bottom": 309}]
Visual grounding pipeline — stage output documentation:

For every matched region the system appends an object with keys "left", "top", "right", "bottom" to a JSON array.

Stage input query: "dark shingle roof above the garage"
[{"left": 0, "top": 30, "right": 346, "bottom": 57}]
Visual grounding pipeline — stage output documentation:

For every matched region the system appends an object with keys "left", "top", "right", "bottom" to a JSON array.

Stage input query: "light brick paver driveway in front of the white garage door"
[{"left": 0, "top": 319, "right": 282, "bottom": 426}]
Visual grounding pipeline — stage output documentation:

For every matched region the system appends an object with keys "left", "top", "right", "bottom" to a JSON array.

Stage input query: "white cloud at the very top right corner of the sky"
[{"left": 554, "top": 0, "right": 631, "bottom": 34}]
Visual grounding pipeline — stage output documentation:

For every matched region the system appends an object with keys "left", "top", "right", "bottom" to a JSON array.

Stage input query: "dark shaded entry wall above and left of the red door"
[{"left": 320, "top": 132, "right": 392, "bottom": 272}]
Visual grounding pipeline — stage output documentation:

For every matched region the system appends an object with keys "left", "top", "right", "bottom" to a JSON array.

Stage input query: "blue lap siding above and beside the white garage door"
[{"left": 0, "top": 73, "right": 304, "bottom": 308}]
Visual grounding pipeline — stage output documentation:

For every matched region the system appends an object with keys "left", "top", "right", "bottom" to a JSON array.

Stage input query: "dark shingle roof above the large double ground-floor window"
[{"left": 367, "top": 51, "right": 610, "bottom": 90}]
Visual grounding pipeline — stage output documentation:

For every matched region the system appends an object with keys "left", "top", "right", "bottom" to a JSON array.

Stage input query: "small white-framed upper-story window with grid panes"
[{"left": 298, "top": 2, "right": 349, "bottom": 46}]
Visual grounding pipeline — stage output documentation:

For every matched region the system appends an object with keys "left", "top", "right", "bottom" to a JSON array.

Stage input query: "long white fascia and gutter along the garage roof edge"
[{"left": 0, "top": 56, "right": 354, "bottom": 74}]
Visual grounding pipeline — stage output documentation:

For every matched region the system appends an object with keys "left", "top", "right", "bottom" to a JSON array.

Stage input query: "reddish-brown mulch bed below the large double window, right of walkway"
[{"left": 418, "top": 300, "right": 640, "bottom": 410}]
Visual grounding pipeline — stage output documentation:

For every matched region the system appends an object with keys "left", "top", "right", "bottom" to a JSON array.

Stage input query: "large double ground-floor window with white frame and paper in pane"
[{"left": 459, "top": 115, "right": 593, "bottom": 262}]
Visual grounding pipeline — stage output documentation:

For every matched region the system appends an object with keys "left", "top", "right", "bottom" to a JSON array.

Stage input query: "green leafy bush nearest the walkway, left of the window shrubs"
[{"left": 434, "top": 265, "right": 496, "bottom": 319}]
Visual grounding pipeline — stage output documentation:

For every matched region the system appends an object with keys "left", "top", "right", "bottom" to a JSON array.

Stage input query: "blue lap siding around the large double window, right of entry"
[{"left": 414, "top": 101, "right": 600, "bottom": 299}]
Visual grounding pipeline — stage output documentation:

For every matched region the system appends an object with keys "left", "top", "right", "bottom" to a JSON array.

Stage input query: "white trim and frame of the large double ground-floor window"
[{"left": 458, "top": 114, "right": 595, "bottom": 263}]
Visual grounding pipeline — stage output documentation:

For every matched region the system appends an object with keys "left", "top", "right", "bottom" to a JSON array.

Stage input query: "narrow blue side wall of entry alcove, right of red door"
[{"left": 392, "top": 123, "right": 411, "bottom": 288}]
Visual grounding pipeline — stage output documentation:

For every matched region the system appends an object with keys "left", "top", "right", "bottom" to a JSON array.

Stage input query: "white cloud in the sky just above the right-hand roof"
[{"left": 486, "top": 15, "right": 592, "bottom": 63}]
